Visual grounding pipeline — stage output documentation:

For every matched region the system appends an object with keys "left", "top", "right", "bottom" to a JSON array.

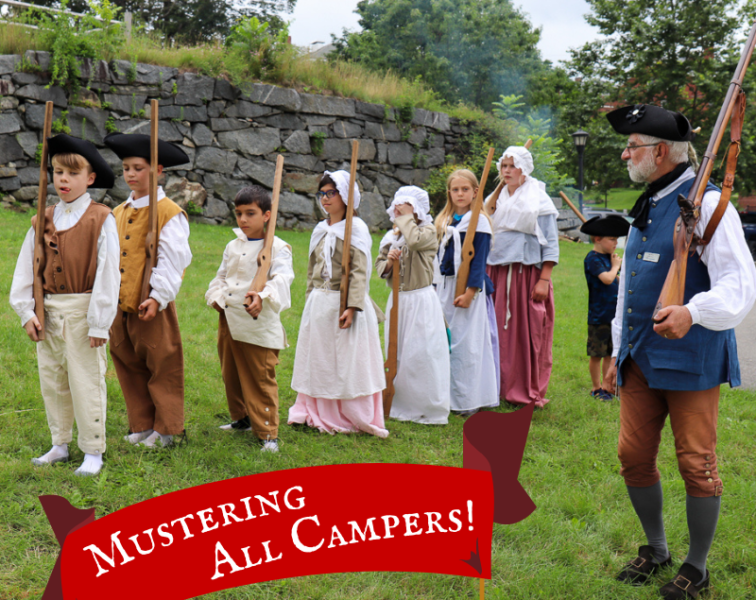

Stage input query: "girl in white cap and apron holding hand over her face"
[{"left": 375, "top": 185, "right": 450, "bottom": 425}]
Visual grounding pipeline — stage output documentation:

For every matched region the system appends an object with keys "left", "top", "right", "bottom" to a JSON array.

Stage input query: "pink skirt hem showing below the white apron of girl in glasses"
[{"left": 289, "top": 392, "right": 388, "bottom": 438}]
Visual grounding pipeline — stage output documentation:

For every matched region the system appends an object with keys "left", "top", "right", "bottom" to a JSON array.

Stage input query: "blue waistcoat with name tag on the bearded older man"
[{"left": 617, "top": 179, "right": 740, "bottom": 391}]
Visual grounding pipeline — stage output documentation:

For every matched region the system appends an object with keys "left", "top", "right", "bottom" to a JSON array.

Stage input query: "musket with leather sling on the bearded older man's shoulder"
[{"left": 653, "top": 17, "right": 756, "bottom": 320}]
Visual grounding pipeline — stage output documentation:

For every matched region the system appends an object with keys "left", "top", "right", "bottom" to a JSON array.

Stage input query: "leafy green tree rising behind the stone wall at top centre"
[{"left": 334, "top": 0, "right": 545, "bottom": 110}]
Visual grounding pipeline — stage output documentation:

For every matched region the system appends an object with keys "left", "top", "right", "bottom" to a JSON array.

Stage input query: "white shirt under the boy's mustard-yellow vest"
[{"left": 121, "top": 186, "right": 192, "bottom": 310}]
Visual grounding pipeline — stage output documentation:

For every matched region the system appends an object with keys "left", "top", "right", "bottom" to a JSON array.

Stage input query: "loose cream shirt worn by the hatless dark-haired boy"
[{"left": 205, "top": 229, "right": 294, "bottom": 349}]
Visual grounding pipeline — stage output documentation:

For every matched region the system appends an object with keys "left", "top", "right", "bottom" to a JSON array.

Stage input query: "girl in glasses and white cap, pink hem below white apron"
[{"left": 288, "top": 171, "right": 388, "bottom": 438}]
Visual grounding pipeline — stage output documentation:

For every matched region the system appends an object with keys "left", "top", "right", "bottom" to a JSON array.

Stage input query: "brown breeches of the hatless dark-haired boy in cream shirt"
[{"left": 218, "top": 313, "right": 278, "bottom": 440}]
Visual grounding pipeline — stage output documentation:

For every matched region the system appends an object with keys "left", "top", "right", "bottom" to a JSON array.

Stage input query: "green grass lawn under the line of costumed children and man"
[{"left": 0, "top": 211, "right": 756, "bottom": 600}]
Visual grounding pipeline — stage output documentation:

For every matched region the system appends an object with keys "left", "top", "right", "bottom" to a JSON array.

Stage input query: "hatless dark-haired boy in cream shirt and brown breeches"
[{"left": 205, "top": 185, "right": 294, "bottom": 452}]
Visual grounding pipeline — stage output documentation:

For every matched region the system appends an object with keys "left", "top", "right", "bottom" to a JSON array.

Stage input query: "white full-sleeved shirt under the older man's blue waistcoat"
[{"left": 612, "top": 168, "right": 756, "bottom": 357}]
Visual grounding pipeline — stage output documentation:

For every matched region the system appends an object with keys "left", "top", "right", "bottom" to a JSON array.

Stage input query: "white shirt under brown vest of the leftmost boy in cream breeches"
[{"left": 10, "top": 193, "right": 121, "bottom": 340}]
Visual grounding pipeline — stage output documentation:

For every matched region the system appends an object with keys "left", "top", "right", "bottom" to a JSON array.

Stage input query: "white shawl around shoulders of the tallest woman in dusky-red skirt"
[{"left": 486, "top": 177, "right": 559, "bottom": 246}]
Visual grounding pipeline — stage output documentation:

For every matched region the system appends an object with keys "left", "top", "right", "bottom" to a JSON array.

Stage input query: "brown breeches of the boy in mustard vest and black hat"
[{"left": 110, "top": 302, "right": 184, "bottom": 435}]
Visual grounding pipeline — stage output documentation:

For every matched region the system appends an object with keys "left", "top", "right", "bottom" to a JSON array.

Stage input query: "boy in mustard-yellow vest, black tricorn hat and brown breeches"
[{"left": 105, "top": 133, "right": 192, "bottom": 448}]
